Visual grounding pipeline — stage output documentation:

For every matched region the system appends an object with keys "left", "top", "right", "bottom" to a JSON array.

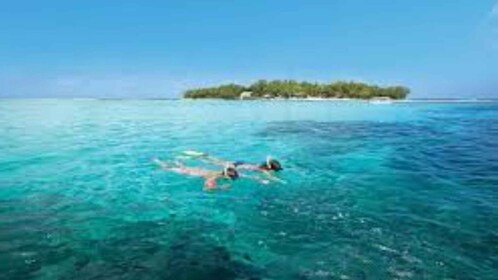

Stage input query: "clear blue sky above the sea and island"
[{"left": 0, "top": 0, "right": 498, "bottom": 98}]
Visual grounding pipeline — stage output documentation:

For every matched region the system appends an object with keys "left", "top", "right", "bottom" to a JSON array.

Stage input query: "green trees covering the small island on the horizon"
[{"left": 183, "top": 80, "right": 410, "bottom": 99}]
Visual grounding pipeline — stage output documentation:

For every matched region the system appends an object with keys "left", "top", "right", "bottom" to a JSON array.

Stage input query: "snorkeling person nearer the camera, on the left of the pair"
[{"left": 153, "top": 158, "right": 239, "bottom": 191}]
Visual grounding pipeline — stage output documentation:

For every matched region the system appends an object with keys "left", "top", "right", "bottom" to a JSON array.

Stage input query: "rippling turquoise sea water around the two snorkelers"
[{"left": 0, "top": 100, "right": 498, "bottom": 280}]
